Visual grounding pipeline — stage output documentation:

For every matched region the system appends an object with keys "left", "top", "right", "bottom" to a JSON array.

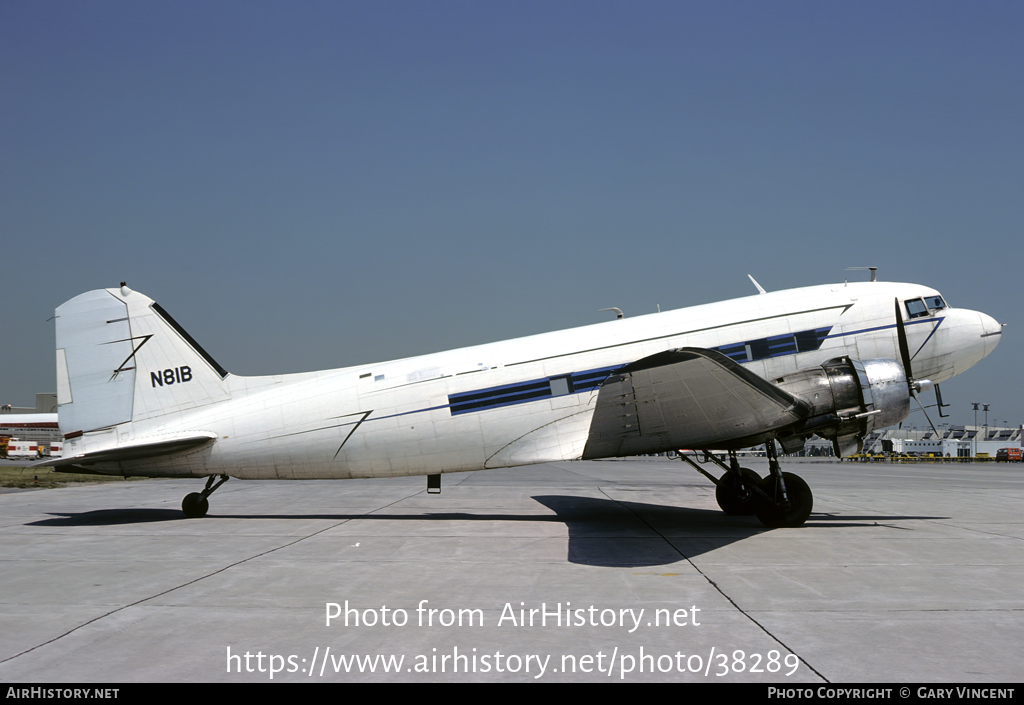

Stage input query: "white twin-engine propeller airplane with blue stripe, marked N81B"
[{"left": 39, "top": 282, "right": 1001, "bottom": 527}]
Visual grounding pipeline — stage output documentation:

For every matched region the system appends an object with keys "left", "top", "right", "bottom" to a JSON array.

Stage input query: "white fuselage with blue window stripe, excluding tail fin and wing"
[{"left": 58, "top": 282, "right": 999, "bottom": 479}]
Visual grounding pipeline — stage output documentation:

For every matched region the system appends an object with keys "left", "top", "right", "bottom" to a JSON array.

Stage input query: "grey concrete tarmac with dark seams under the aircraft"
[{"left": 0, "top": 459, "right": 1024, "bottom": 685}]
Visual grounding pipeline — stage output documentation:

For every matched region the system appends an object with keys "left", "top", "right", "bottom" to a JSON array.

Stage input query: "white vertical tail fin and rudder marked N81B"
[{"left": 56, "top": 286, "right": 230, "bottom": 438}]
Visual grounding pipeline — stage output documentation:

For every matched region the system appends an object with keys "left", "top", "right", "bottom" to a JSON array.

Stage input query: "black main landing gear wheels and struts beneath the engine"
[{"left": 679, "top": 441, "right": 814, "bottom": 529}]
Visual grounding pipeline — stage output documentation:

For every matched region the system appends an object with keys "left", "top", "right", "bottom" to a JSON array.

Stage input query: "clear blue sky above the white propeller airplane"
[{"left": 0, "top": 0, "right": 1024, "bottom": 424}]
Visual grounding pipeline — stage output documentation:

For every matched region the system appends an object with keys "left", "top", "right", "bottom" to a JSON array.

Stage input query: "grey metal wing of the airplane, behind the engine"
[{"left": 583, "top": 347, "right": 808, "bottom": 460}]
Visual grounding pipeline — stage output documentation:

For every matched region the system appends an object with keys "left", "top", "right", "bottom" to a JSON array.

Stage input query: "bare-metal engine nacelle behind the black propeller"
[{"left": 772, "top": 357, "right": 910, "bottom": 456}]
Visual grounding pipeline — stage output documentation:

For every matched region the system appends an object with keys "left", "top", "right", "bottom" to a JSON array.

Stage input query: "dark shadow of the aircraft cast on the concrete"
[{"left": 28, "top": 495, "right": 945, "bottom": 568}]
